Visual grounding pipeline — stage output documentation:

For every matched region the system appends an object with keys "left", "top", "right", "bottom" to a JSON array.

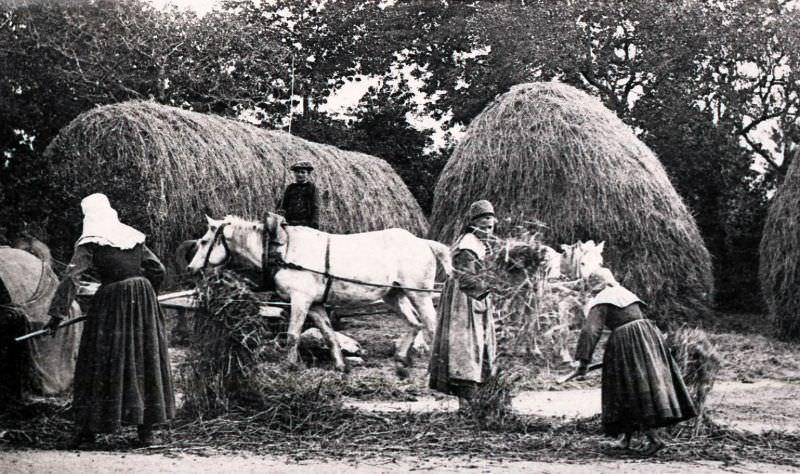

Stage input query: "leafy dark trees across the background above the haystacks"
[{"left": 0, "top": 0, "right": 800, "bottom": 312}]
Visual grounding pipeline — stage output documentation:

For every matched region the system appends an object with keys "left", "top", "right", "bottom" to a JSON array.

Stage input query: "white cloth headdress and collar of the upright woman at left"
[{"left": 75, "top": 193, "right": 145, "bottom": 250}]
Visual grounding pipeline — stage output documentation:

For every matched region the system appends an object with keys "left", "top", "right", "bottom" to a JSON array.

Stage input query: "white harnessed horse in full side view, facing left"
[{"left": 187, "top": 213, "right": 452, "bottom": 375}]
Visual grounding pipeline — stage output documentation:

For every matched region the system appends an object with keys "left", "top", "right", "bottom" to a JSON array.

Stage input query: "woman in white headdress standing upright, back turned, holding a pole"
[{"left": 46, "top": 193, "right": 175, "bottom": 447}]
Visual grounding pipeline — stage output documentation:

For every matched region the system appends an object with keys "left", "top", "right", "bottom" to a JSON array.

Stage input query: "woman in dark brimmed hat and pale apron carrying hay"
[{"left": 430, "top": 200, "right": 497, "bottom": 407}]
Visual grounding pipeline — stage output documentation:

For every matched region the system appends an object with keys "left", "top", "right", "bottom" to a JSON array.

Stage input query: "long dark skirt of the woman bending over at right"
[{"left": 602, "top": 319, "right": 697, "bottom": 436}]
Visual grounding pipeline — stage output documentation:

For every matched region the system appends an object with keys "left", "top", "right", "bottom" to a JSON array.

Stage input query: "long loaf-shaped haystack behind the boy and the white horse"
[{"left": 46, "top": 101, "right": 427, "bottom": 264}]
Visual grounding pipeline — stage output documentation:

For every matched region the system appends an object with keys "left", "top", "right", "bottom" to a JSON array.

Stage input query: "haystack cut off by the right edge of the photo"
[{"left": 759, "top": 151, "right": 800, "bottom": 339}]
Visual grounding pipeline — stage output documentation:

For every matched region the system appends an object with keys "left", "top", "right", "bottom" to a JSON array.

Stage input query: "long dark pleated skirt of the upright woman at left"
[{"left": 73, "top": 277, "right": 175, "bottom": 433}]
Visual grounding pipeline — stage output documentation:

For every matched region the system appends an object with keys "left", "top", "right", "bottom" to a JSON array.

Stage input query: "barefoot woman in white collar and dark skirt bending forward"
[{"left": 575, "top": 267, "right": 697, "bottom": 455}]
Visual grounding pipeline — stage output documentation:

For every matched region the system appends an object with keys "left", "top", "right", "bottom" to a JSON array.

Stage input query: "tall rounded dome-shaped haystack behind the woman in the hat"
[{"left": 430, "top": 83, "right": 713, "bottom": 322}]
